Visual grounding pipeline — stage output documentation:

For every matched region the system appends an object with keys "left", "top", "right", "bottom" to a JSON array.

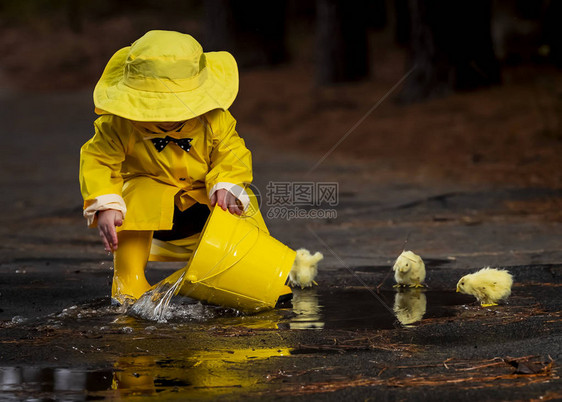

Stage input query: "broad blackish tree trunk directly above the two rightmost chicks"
[{"left": 401, "top": 0, "right": 500, "bottom": 102}]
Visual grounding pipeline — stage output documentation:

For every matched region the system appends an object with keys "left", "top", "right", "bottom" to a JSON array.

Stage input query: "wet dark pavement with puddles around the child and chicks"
[{"left": 0, "top": 88, "right": 562, "bottom": 401}]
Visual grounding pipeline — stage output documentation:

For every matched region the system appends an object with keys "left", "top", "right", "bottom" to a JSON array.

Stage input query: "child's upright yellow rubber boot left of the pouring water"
[{"left": 111, "top": 230, "right": 153, "bottom": 304}]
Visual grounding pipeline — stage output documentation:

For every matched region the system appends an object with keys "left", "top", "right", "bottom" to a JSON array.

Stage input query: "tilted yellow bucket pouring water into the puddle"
[{"left": 179, "top": 206, "right": 296, "bottom": 312}]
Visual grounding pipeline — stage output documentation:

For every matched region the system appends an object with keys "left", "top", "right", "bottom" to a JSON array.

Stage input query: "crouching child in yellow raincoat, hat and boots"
[{"left": 80, "top": 31, "right": 261, "bottom": 303}]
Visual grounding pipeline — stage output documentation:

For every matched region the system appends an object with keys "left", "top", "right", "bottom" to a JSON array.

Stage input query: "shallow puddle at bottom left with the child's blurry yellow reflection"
[{"left": 0, "top": 347, "right": 290, "bottom": 401}]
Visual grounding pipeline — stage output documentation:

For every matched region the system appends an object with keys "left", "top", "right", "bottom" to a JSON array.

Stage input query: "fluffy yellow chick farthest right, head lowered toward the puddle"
[{"left": 457, "top": 267, "right": 513, "bottom": 307}]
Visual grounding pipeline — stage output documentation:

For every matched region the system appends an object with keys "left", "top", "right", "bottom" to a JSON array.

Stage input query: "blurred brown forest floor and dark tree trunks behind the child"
[{"left": 0, "top": 0, "right": 562, "bottom": 188}]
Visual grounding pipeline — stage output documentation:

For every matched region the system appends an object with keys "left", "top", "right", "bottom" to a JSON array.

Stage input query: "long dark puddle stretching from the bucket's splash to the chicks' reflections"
[{"left": 25, "top": 287, "right": 475, "bottom": 330}]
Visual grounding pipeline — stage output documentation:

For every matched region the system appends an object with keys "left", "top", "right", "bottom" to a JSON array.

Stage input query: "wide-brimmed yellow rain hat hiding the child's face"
[{"left": 94, "top": 31, "right": 238, "bottom": 122}]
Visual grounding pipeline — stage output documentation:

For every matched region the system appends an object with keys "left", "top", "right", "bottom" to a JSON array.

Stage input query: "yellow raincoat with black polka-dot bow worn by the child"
[{"left": 80, "top": 109, "right": 252, "bottom": 230}]
